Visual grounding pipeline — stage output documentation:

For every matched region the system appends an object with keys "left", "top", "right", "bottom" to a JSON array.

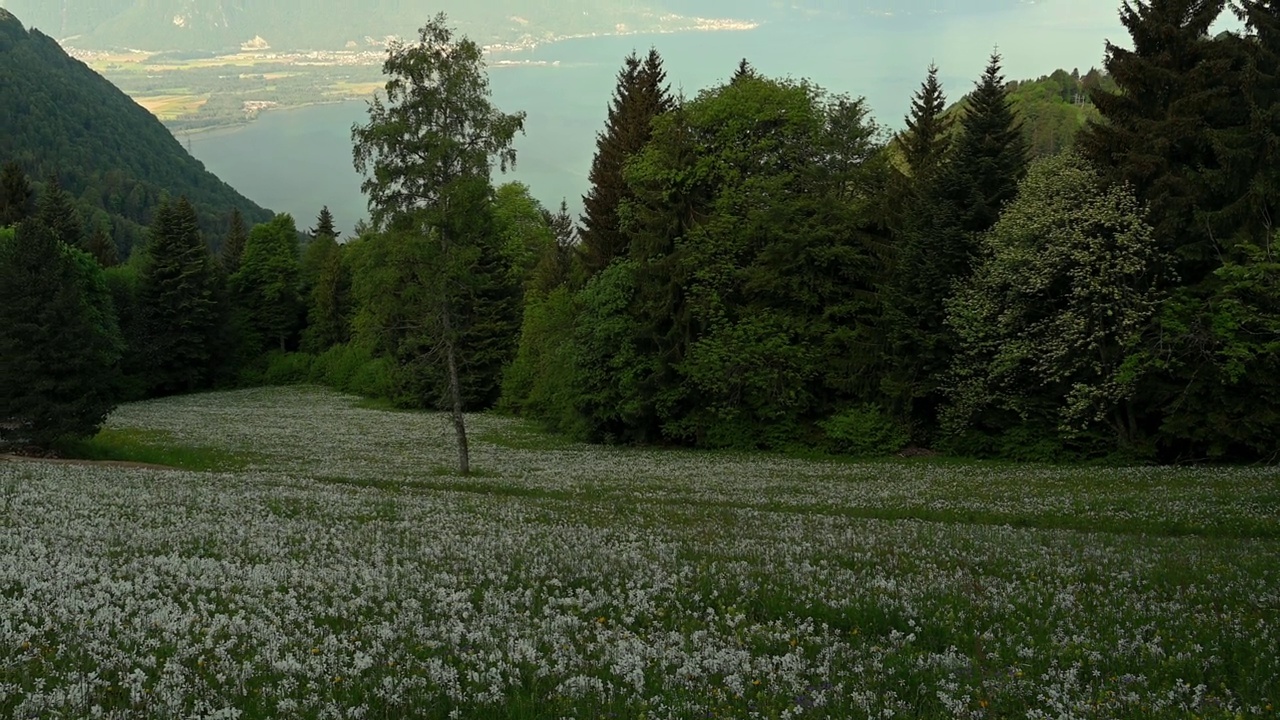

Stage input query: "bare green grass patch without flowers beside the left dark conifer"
[{"left": 58, "top": 428, "right": 253, "bottom": 473}]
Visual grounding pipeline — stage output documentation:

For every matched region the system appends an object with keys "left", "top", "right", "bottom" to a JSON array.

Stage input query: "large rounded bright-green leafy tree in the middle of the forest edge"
[{"left": 627, "top": 77, "right": 883, "bottom": 447}]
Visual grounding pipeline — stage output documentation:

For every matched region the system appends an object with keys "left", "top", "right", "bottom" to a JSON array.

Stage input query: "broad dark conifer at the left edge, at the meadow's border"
[{"left": 0, "top": 219, "right": 123, "bottom": 447}]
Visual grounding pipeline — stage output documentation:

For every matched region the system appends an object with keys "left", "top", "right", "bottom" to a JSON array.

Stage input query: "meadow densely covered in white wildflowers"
[{"left": 0, "top": 388, "right": 1280, "bottom": 719}]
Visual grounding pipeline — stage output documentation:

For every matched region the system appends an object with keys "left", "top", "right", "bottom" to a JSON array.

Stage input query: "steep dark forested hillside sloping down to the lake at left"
[{"left": 0, "top": 10, "right": 270, "bottom": 256}]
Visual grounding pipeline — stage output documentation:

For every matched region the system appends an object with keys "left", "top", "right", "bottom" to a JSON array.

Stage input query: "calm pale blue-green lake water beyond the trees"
[{"left": 180, "top": 0, "right": 1128, "bottom": 235}]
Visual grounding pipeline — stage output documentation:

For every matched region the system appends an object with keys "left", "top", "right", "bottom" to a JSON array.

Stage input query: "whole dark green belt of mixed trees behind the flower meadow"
[{"left": 0, "top": 0, "right": 1280, "bottom": 468}]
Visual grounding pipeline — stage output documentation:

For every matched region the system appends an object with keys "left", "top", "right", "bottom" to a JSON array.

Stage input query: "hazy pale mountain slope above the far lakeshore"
[{"left": 3, "top": 0, "right": 696, "bottom": 50}]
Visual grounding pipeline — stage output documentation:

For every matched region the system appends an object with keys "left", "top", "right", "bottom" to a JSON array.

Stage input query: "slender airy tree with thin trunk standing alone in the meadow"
[{"left": 352, "top": 14, "right": 525, "bottom": 474}]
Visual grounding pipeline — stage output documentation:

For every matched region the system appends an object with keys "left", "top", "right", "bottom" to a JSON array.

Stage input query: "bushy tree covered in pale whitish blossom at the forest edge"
[{"left": 945, "top": 154, "right": 1166, "bottom": 445}]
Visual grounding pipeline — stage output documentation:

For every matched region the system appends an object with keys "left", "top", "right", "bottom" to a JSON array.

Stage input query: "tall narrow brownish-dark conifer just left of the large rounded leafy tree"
[{"left": 581, "top": 50, "right": 672, "bottom": 274}]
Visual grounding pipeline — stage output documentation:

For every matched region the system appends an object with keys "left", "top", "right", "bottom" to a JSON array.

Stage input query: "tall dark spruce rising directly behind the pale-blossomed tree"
[{"left": 1078, "top": 0, "right": 1230, "bottom": 284}]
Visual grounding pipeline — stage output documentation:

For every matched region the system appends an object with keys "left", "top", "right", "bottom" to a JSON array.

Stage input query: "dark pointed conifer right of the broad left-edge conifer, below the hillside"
[{"left": 138, "top": 197, "right": 218, "bottom": 395}]
